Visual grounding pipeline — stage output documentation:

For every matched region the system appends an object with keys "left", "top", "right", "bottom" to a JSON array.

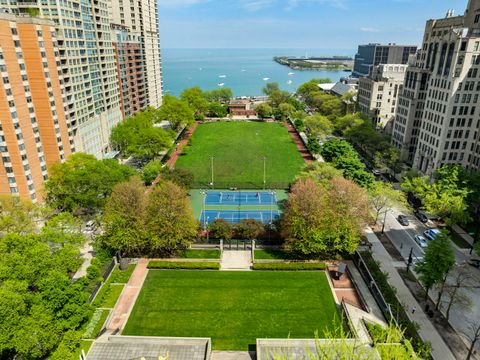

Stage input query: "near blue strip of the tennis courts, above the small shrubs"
[{"left": 200, "top": 210, "right": 280, "bottom": 225}]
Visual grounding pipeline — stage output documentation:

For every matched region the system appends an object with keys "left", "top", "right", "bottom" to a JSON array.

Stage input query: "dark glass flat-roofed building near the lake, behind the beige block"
[{"left": 352, "top": 44, "right": 417, "bottom": 77}]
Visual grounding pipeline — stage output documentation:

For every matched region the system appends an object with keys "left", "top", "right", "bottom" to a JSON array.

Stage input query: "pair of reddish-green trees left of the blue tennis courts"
[{"left": 100, "top": 177, "right": 199, "bottom": 256}]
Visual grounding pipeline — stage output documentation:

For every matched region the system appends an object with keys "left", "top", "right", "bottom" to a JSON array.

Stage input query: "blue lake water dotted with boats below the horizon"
[{"left": 162, "top": 49, "right": 355, "bottom": 96}]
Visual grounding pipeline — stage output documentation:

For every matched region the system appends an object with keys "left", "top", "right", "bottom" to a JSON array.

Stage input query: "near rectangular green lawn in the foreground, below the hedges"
[{"left": 122, "top": 270, "right": 339, "bottom": 351}]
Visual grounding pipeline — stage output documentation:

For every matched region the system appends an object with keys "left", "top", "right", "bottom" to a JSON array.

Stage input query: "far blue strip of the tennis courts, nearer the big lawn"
[{"left": 205, "top": 191, "right": 277, "bottom": 205}]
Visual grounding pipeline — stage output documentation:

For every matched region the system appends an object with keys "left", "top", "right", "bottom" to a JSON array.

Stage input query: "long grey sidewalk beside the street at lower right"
[{"left": 366, "top": 228, "right": 455, "bottom": 360}]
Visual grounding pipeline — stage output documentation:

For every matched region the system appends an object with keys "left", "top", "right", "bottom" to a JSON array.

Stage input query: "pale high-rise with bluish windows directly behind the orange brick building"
[{"left": 0, "top": 0, "right": 122, "bottom": 158}]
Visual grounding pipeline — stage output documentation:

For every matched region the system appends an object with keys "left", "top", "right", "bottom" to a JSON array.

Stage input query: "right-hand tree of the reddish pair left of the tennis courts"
[{"left": 146, "top": 181, "right": 199, "bottom": 255}]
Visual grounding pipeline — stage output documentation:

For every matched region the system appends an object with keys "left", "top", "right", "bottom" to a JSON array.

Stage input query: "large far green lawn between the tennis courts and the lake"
[{"left": 175, "top": 122, "right": 304, "bottom": 189}]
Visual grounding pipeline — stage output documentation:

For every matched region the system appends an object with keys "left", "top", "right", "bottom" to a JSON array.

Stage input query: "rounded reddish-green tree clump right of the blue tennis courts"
[{"left": 281, "top": 177, "right": 369, "bottom": 257}]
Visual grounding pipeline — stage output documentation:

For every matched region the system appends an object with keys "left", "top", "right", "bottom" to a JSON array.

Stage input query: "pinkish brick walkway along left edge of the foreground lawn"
[{"left": 107, "top": 259, "right": 149, "bottom": 331}]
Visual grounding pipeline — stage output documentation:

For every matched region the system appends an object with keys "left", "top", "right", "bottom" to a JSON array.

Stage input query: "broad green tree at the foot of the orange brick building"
[{"left": 45, "top": 153, "right": 135, "bottom": 213}]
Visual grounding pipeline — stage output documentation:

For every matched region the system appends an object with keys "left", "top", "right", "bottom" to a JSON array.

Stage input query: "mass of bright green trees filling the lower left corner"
[{"left": 0, "top": 196, "right": 96, "bottom": 360}]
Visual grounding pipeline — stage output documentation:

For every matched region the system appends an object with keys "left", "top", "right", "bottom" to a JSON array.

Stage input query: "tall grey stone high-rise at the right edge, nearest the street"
[{"left": 392, "top": 0, "right": 480, "bottom": 175}]
